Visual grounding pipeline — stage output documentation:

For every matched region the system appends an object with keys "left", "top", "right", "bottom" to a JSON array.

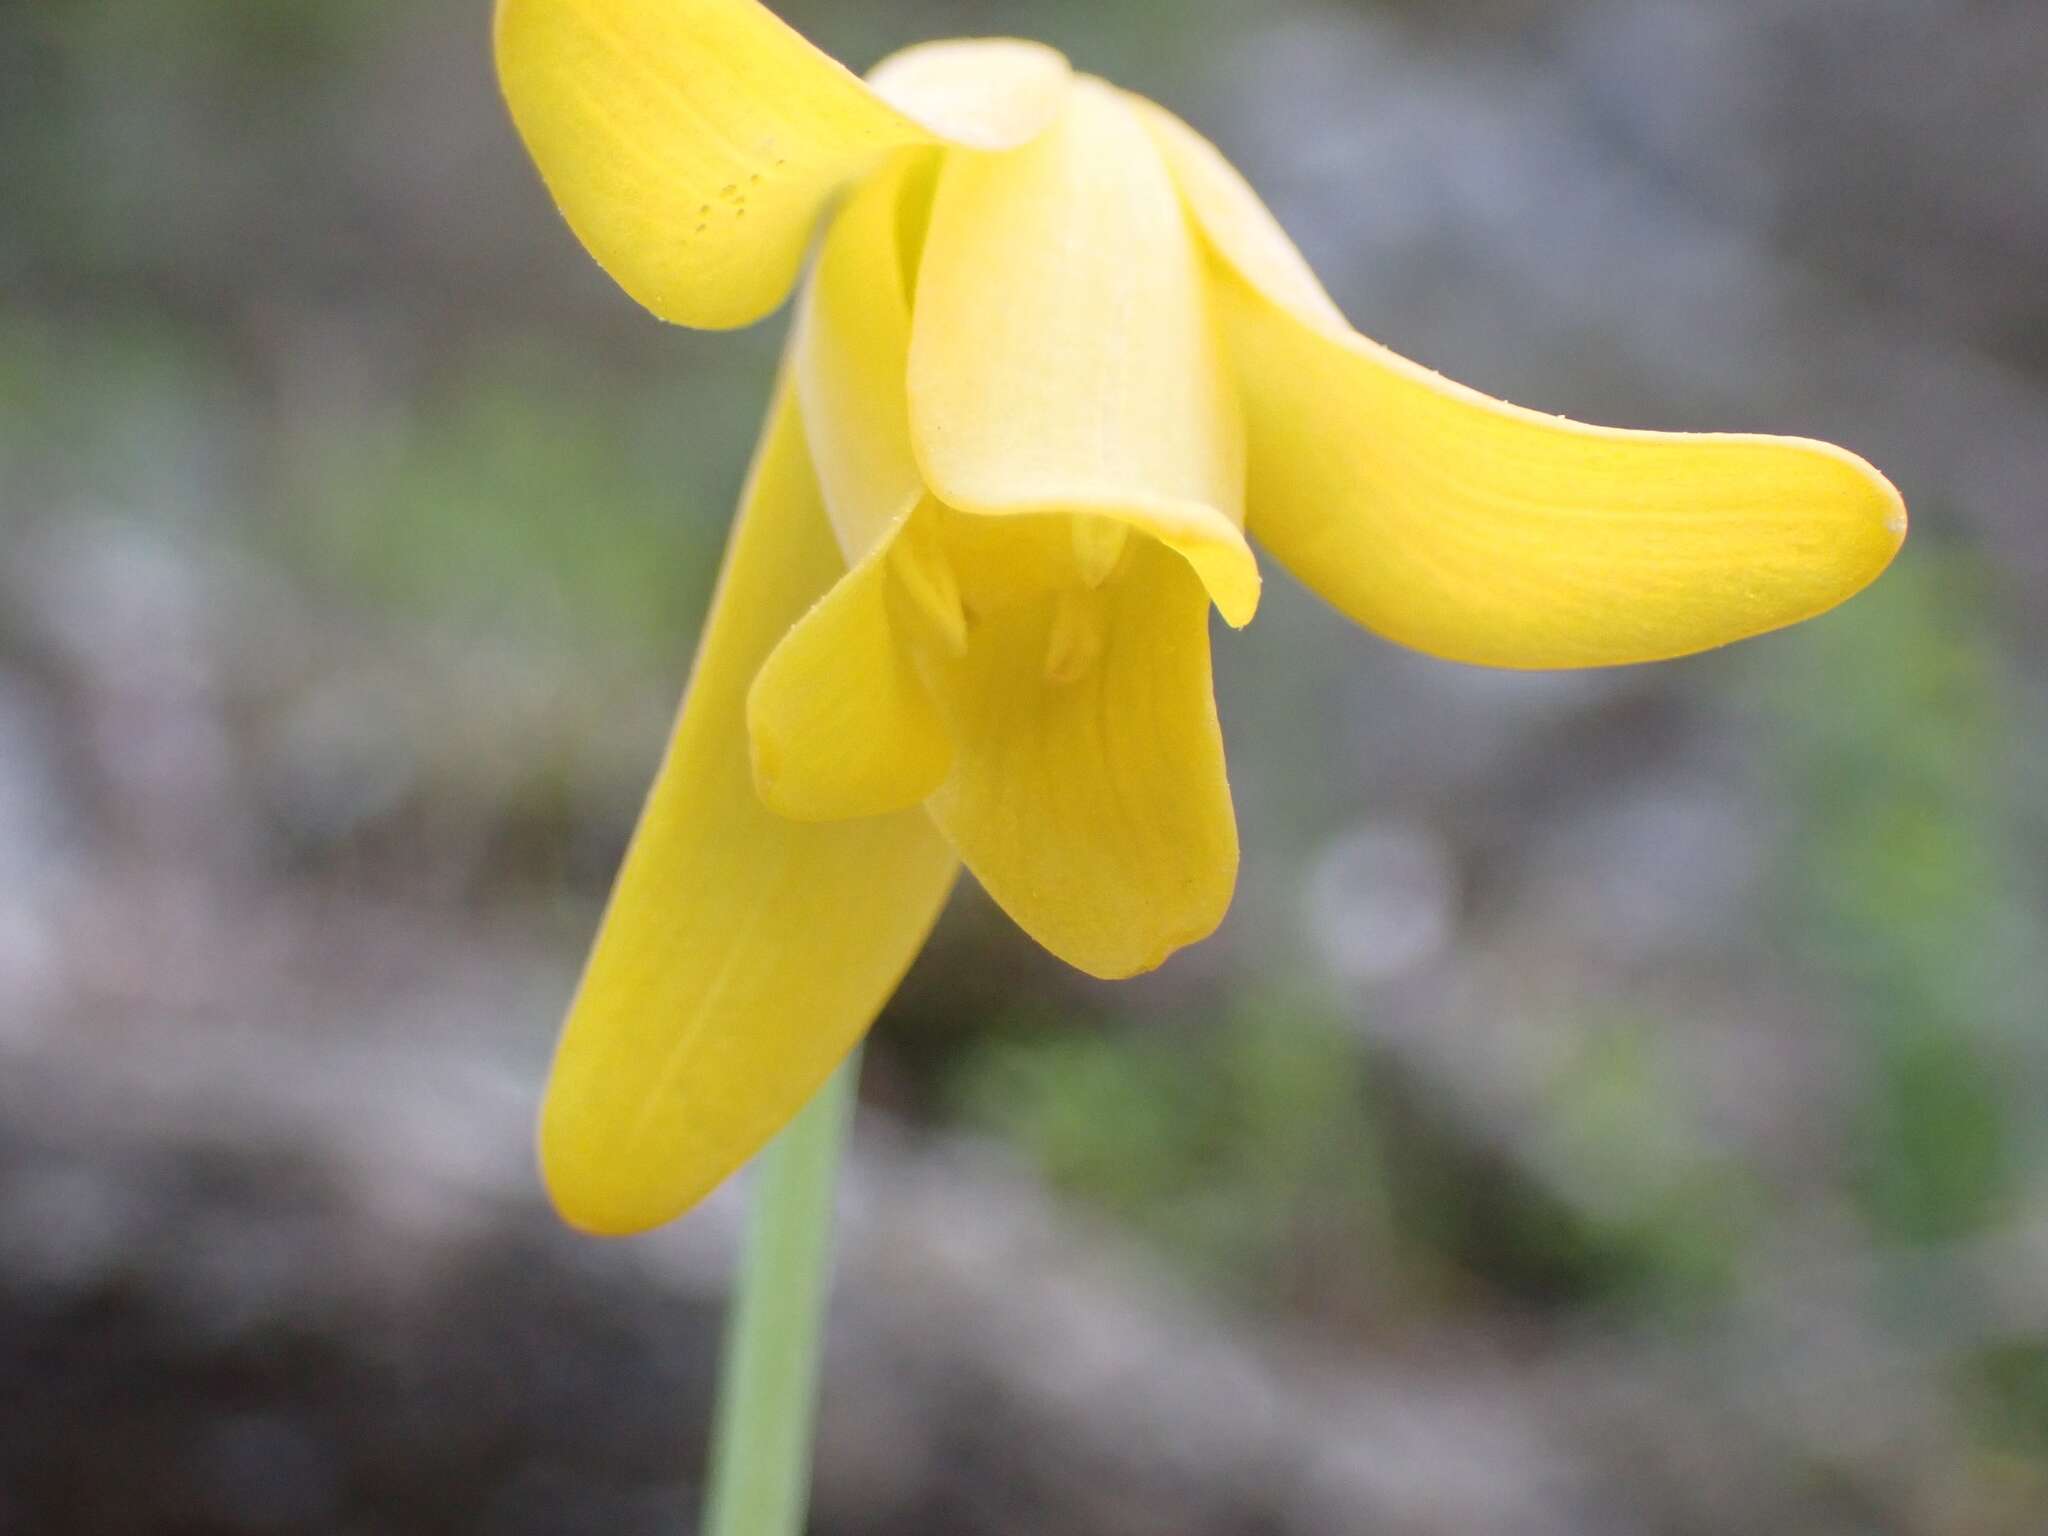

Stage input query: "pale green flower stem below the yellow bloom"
[{"left": 705, "top": 1051, "right": 860, "bottom": 1536}]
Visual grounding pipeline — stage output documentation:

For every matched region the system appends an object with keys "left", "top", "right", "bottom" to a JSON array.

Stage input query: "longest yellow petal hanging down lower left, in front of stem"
[{"left": 541, "top": 385, "right": 956, "bottom": 1233}]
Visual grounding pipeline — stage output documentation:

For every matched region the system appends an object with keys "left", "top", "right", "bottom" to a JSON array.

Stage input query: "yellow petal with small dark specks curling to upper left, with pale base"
[{"left": 496, "top": 0, "right": 1065, "bottom": 328}]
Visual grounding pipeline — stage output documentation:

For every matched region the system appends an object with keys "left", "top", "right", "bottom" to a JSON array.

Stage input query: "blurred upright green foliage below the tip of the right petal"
[{"left": 1778, "top": 541, "right": 2048, "bottom": 1241}]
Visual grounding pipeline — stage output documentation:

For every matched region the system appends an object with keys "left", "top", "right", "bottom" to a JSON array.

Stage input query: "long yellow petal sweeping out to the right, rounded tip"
[{"left": 1145, "top": 97, "right": 1907, "bottom": 668}]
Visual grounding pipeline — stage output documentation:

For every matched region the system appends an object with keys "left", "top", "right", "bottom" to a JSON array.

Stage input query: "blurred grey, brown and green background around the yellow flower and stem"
[{"left": 0, "top": 0, "right": 2048, "bottom": 1536}]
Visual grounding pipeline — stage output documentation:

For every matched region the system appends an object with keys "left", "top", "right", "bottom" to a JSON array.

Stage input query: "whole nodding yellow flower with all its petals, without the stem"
[{"left": 496, "top": 0, "right": 1905, "bottom": 1233}]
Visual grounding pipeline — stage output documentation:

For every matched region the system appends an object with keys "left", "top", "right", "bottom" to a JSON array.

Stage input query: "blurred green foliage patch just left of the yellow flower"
[{"left": 287, "top": 350, "right": 745, "bottom": 662}]
